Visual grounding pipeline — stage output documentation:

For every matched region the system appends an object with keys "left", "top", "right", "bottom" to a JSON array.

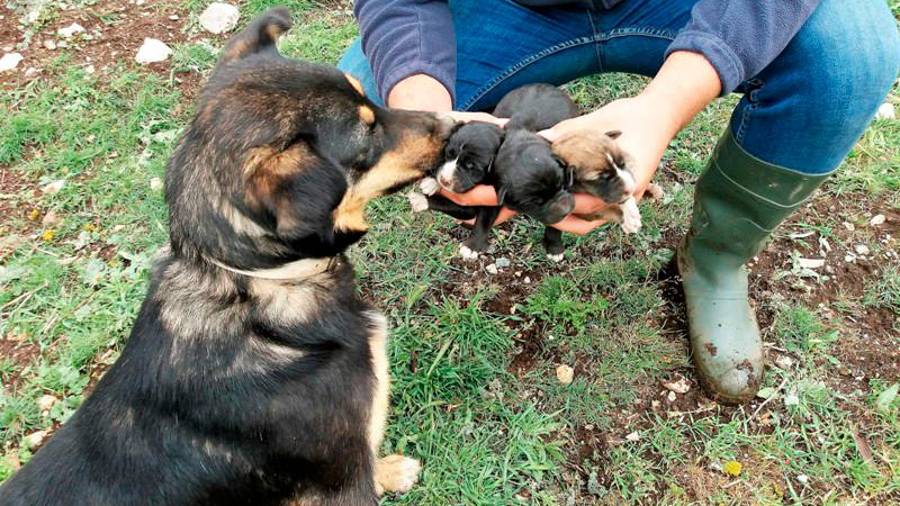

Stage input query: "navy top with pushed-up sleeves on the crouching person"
[{"left": 354, "top": 0, "right": 821, "bottom": 105}]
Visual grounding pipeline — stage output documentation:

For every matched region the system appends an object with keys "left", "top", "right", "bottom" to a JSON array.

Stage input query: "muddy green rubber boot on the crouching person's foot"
[{"left": 678, "top": 129, "right": 828, "bottom": 404}]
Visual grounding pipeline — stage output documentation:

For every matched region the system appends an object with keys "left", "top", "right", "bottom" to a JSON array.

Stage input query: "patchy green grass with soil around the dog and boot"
[{"left": 0, "top": 0, "right": 900, "bottom": 505}]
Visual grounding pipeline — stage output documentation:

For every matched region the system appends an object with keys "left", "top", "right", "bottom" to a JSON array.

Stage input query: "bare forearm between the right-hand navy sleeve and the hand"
[{"left": 641, "top": 51, "right": 722, "bottom": 138}]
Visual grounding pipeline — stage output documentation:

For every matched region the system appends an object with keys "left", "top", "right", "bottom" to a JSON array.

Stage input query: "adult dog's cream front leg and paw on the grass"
[{"left": 369, "top": 313, "right": 422, "bottom": 496}]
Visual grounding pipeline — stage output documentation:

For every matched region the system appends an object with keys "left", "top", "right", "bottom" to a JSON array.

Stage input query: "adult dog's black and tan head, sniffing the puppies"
[{"left": 166, "top": 8, "right": 454, "bottom": 270}]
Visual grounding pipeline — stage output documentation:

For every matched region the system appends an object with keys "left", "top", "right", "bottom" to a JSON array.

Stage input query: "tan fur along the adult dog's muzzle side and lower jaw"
[{"left": 334, "top": 133, "right": 441, "bottom": 232}]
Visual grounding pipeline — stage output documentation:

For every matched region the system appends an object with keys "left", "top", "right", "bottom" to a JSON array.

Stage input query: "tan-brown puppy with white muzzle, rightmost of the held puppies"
[{"left": 552, "top": 130, "right": 644, "bottom": 234}]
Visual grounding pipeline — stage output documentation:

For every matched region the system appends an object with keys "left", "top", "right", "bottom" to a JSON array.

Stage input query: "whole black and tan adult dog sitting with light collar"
[{"left": 0, "top": 9, "right": 453, "bottom": 506}]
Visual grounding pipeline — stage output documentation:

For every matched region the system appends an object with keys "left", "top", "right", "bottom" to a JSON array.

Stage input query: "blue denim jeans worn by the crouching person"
[{"left": 338, "top": 0, "right": 900, "bottom": 174}]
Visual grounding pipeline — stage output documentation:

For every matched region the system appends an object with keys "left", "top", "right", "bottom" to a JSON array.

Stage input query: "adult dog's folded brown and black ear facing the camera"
[{"left": 242, "top": 140, "right": 361, "bottom": 249}]
